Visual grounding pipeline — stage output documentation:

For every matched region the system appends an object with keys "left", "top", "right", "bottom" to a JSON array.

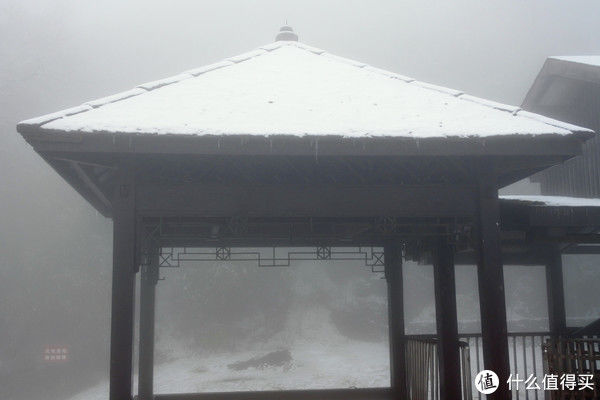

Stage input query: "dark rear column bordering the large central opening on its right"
[{"left": 384, "top": 241, "right": 407, "bottom": 400}]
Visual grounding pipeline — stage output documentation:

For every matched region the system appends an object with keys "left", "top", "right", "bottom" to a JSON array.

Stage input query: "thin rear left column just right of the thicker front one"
[{"left": 138, "top": 248, "right": 160, "bottom": 400}]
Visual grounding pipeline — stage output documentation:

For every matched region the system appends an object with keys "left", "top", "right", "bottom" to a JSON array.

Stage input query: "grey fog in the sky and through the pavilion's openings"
[{"left": 0, "top": 0, "right": 600, "bottom": 400}]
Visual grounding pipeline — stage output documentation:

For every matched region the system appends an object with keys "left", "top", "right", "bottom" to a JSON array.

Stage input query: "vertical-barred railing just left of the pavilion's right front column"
[{"left": 405, "top": 336, "right": 472, "bottom": 400}]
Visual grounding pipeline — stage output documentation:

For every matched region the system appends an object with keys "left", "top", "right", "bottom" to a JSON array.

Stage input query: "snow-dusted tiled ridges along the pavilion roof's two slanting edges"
[{"left": 17, "top": 41, "right": 593, "bottom": 138}]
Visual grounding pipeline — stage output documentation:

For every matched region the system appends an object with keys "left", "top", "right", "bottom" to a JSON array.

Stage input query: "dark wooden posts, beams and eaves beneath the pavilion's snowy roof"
[{"left": 18, "top": 125, "right": 591, "bottom": 400}]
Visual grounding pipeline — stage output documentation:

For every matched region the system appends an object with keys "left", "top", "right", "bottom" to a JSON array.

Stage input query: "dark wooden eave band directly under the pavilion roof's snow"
[{"left": 20, "top": 127, "right": 589, "bottom": 162}]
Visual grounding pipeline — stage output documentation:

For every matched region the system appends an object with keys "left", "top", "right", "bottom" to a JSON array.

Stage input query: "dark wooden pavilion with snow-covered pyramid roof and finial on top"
[{"left": 17, "top": 27, "right": 600, "bottom": 400}]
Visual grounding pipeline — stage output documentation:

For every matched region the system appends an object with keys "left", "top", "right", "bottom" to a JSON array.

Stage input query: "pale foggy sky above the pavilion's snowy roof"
[{"left": 0, "top": 0, "right": 600, "bottom": 117}]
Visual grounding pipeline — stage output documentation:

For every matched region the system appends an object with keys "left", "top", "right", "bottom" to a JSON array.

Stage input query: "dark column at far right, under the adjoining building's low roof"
[{"left": 545, "top": 245, "right": 567, "bottom": 337}]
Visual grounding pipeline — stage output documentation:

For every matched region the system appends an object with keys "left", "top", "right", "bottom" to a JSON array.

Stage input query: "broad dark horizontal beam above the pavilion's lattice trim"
[{"left": 136, "top": 184, "right": 475, "bottom": 218}]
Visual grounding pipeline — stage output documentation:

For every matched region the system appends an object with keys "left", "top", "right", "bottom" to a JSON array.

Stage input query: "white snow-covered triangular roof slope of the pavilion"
[{"left": 19, "top": 41, "right": 589, "bottom": 138}]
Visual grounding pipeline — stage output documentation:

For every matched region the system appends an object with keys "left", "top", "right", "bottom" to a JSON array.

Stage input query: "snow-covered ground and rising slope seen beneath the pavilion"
[{"left": 70, "top": 308, "right": 390, "bottom": 400}]
